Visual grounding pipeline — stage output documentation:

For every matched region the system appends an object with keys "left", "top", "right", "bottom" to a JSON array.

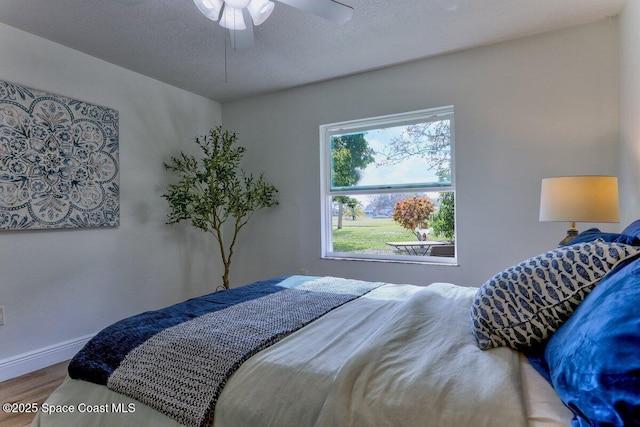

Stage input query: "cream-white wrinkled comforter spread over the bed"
[{"left": 34, "top": 283, "right": 527, "bottom": 427}]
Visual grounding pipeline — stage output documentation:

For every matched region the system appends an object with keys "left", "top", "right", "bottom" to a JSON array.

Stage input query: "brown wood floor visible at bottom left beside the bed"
[{"left": 0, "top": 361, "right": 69, "bottom": 427}]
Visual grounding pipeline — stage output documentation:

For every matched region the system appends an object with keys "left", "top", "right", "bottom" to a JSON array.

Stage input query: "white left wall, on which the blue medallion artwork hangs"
[{"left": 0, "top": 25, "right": 221, "bottom": 381}]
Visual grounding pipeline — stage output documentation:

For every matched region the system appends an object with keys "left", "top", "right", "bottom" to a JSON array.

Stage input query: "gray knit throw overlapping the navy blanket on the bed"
[{"left": 107, "top": 277, "right": 382, "bottom": 426}]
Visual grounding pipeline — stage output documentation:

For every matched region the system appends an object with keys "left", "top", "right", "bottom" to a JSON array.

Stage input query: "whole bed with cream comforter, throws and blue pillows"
[{"left": 32, "top": 223, "right": 640, "bottom": 427}]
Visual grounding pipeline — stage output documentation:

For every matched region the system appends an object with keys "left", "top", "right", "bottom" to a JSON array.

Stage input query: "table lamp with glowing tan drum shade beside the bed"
[{"left": 540, "top": 175, "right": 620, "bottom": 245}]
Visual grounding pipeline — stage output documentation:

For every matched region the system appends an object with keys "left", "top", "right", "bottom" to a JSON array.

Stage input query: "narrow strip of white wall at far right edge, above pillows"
[{"left": 620, "top": 0, "right": 640, "bottom": 223}]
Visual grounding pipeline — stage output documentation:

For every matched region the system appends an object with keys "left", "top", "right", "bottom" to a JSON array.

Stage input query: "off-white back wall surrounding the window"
[{"left": 223, "top": 19, "right": 619, "bottom": 285}]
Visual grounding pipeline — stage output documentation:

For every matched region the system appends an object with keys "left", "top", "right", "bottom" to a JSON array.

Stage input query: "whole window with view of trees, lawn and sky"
[{"left": 320, "top": 106, "right": 456, "bottom": 264}]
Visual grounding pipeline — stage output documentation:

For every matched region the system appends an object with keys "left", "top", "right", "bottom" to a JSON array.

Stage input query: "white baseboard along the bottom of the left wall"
[{"left": 0, "top": 335, "right": 93, "bottom": 382}]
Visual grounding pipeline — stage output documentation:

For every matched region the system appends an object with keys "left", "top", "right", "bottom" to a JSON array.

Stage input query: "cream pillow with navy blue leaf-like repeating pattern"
[{"left": 471, "top": 240, "right": 640, "bottom": 350}]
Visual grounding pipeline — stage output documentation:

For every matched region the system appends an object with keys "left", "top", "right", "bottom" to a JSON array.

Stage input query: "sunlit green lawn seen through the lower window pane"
[{"left": 333, "top": 217, "right": 436, "bottom": 254}]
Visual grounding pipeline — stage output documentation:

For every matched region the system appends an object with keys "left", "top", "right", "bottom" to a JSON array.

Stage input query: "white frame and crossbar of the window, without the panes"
[{"left": 319, "top": 105, "right": 458, "bottom": 265}]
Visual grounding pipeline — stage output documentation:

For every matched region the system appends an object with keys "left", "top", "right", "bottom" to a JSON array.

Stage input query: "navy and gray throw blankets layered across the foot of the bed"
[{"left": 69, "top": 276, "right": 381, "bottom": 426}]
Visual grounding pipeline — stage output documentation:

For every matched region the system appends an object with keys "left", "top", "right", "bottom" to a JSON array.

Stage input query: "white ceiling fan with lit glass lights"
[{"left": 193, "top": 0, "right": 353, "bottom": 49}]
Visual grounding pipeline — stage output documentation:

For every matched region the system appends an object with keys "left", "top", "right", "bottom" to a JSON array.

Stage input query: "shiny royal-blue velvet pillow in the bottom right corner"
[{"left": 543, "top": 258, "right": 640, "bottom": 427}]
